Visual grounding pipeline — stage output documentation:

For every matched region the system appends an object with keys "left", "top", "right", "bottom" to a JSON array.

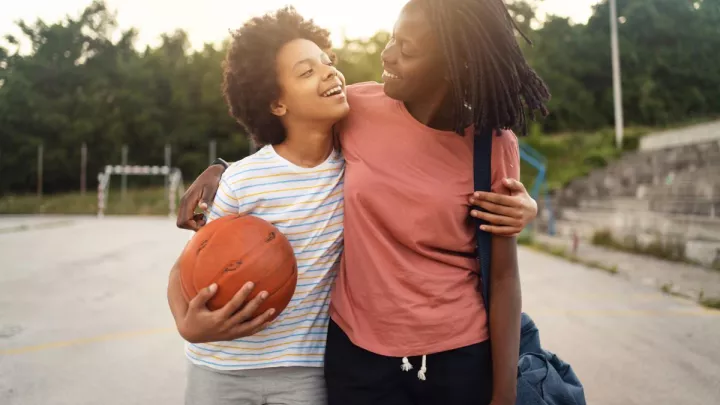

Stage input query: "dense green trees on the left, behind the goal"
[{"left": 0, "top": 2, "right": 248, "bottom": 193}]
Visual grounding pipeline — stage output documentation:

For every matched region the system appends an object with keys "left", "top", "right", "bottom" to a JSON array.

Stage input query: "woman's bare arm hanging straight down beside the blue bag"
[{"left": 490, "top": 236, "right": 522, "bottom": 405}]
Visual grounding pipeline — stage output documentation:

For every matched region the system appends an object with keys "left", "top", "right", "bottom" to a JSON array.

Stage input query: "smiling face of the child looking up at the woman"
[{"left": 271, "top": 39, "right": 350, "bottom": 124}]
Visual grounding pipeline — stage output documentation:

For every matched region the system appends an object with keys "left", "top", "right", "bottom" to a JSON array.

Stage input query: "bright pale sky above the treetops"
[{"left": 0, "top": 0, "right": 599, "bottom": 48}]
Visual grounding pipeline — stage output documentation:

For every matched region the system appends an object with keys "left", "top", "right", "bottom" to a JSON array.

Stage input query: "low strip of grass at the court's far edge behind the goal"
[{"left": 0, "top": 187, "right": 174, "bottom": 215}]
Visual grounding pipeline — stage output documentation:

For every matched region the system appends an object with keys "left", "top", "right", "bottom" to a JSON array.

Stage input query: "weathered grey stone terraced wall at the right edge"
[{"left": 538, "top": 122, "right": 720, "bottom": 266}]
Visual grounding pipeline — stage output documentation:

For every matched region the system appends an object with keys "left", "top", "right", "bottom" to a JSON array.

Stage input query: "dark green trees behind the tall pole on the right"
[{"left": 516, "top": 0, "right": 720, "bottom": 132}]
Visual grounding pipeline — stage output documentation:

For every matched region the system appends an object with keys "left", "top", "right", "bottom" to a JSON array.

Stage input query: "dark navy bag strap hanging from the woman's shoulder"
[{"left": 473, "top": 129, "right": 493, "bottom": 312}]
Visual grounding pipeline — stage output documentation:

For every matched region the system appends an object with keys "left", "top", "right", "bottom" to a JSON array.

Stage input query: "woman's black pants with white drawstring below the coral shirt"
[{"left": 325, "top": 321, "right": 492, "bottom": 405}]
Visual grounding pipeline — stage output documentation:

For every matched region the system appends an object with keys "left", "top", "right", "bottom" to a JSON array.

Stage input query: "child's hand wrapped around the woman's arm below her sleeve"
[{"left": 470, "top": 179, "right": 537, "bottom": 236}]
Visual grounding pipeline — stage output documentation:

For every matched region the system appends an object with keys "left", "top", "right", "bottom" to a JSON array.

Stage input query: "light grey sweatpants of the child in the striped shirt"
[{"left": 185, "top": 364, "right": 327, "bottom": 405}]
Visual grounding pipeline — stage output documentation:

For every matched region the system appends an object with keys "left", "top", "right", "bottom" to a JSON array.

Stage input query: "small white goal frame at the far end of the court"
[{"left": 98, "top": 165, "right": 185, "bottom": 218}]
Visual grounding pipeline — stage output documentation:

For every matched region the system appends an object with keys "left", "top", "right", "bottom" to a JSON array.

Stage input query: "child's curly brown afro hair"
[{"left": 223, "top": 7, "right": 332, "bottom": 146}]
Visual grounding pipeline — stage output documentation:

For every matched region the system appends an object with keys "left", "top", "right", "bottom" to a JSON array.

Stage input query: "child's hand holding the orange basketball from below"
[{"left": 177, "top": 283, "right": 275, "bottom": 343}]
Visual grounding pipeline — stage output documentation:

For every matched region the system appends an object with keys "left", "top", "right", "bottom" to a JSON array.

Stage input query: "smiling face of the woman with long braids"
[{"left": 382, "top": 3, "right": 448, "bottom": 103}]
